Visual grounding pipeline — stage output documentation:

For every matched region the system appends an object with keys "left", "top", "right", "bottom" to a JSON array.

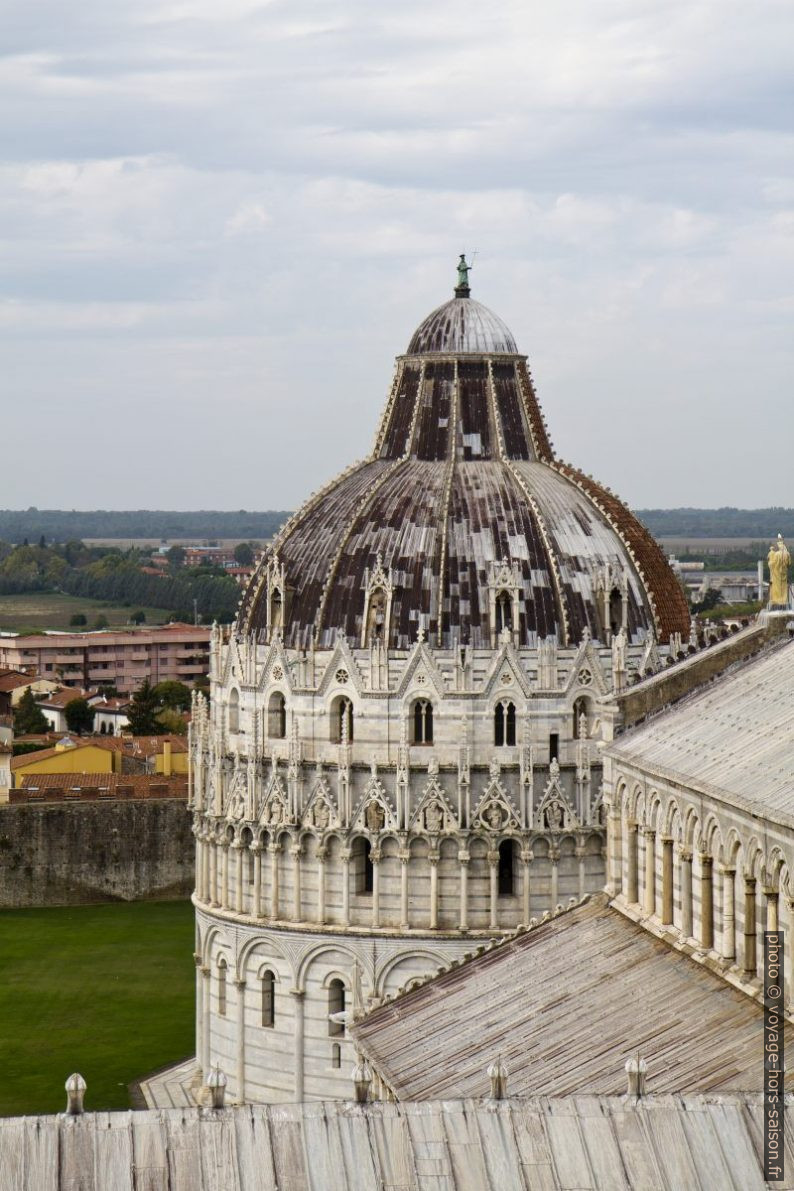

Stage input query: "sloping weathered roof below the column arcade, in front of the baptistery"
[{"left": 351, "top": 894, "right": 794, "bottom": 1100}]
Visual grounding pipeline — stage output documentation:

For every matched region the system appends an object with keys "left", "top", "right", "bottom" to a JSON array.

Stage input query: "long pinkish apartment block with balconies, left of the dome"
[{"left": 0, "top": 624, "right": 210, "bottom": 694}]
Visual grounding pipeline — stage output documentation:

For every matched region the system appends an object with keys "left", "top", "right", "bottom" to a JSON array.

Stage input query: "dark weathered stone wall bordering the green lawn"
[{"left": 0, "top": 799, "right": 194, "bottom": 909}]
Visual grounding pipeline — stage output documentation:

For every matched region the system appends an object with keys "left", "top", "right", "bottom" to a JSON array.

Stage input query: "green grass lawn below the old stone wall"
[{"left": 0, "top": 902, "right": 195, "bottom": 1116}]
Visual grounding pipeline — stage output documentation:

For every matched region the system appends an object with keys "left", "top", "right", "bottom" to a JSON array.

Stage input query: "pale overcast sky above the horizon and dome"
[{"left": 0, "top": 0, "right": 794, "bottom": 509}]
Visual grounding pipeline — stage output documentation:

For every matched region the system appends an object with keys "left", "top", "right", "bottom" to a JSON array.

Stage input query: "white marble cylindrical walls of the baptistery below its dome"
[{"left": 190, "top": 630, "right": 666, "bottom": 1100}]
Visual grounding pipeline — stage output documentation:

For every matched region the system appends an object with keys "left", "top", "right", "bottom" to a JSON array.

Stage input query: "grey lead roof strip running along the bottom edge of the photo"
[{"left": 0, "top": 1090, "right": 780, "bottom": 1191}]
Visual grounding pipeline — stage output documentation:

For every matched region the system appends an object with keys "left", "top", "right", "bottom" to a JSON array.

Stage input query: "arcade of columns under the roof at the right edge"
[{"left": 604, "top": 750, "right": 794, "bottom": 1014}]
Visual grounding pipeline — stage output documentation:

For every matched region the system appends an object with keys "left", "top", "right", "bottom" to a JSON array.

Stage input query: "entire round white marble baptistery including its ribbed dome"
[{"left": 190, "top": 272, "right": 698, "bottom": 1100}]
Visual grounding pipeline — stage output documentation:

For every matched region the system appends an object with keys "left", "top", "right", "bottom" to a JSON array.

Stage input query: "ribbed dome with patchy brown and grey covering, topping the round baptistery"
[{"left": 240, "top": 267, "right": 689, "bottom": 649}]
